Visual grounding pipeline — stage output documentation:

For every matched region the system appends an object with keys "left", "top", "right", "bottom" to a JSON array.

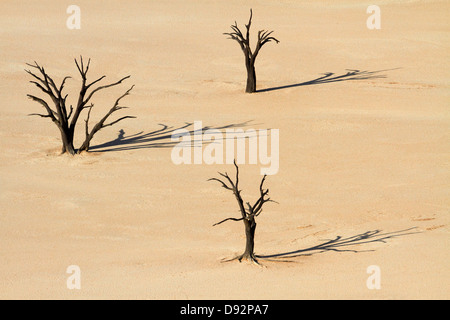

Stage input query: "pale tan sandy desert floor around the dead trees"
[{"left": 0, "top": 0, "right": 450, "bottom": 299}]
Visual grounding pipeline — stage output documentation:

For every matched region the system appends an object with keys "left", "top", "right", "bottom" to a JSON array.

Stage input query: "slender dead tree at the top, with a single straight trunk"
[{"left": 224, "top": 9, "right": 280, "bottom": 93}]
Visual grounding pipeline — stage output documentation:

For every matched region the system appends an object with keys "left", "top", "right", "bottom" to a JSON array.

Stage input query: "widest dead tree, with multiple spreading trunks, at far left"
[{"left": 25, "top": 57, "right": 135, "bottom": 155}]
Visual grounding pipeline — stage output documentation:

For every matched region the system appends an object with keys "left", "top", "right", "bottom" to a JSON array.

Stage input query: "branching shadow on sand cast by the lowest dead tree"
[{"left": 256, "top": 227, "right": 420, "bottom": 262}]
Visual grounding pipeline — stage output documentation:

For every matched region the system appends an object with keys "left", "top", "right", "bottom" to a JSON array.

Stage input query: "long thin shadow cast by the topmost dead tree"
[{"left": 256, "top": 68, "right": 400, "bottom": 92}]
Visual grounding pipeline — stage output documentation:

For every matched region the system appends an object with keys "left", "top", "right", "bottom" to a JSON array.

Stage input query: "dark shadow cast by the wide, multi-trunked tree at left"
[{"left": 89, "top": 120, "right": 253, "bottom": 152}]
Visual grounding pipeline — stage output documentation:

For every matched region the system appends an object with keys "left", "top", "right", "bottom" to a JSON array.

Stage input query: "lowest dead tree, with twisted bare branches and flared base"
[{"left": 208, "top": 161, "right": 275, "bottom": 264}]
